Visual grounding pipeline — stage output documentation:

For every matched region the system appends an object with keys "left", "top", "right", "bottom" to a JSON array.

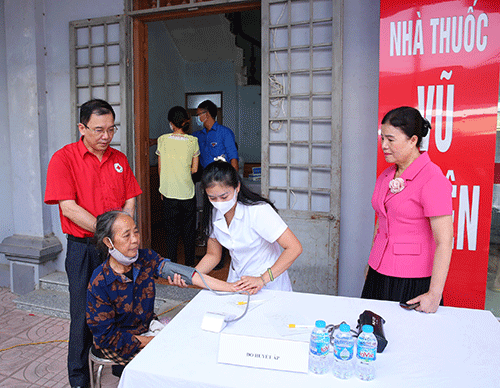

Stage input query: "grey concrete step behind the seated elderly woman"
[{"left": 14, "top": 272, "right": 200, "bottom": 319}]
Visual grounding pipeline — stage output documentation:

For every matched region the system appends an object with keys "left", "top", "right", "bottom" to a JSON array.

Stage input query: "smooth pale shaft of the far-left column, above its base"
[{"left": 4, "top": 1, "right": 47, "bottom": 236}]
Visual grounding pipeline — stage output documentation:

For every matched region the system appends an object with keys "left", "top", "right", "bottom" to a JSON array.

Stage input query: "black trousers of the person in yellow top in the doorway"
[{"left": 163, "top": 197, "right": 196, "bottom": 267}]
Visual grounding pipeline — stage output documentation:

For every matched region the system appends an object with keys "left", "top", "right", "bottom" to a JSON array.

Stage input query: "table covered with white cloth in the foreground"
[{"left": 119, "top": 291, "right": 500, "bottom": 388}]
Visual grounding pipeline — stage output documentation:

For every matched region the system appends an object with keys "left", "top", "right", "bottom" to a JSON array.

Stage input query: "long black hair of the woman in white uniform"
[{"left": 201, "top": 161, "right": 278, "bottom": 239}]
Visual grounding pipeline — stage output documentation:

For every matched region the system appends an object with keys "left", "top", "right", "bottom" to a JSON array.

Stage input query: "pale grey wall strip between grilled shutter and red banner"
[{"left": 339, "top": 0, "right": 380, "bottom": 296}]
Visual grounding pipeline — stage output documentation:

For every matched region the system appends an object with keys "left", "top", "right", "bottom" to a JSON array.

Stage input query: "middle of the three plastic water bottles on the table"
[{"left": 333, "top": 323, "right": 354, "bottom": 379}]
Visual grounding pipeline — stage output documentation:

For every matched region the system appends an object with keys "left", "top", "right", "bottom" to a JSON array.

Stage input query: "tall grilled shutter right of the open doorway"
[{"left": 262, "top": 0, "right": 341, "bottom": 218}]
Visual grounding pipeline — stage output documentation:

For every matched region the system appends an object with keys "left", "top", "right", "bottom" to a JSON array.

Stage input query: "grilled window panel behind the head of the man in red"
[{"left": 70, "top": 16, "right": 132, "bottom": 157}]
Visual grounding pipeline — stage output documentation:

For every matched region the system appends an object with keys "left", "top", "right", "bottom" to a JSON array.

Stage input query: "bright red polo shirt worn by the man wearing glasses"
[{"left": 44, "top": 137, "right": 142, "bottom": 237}]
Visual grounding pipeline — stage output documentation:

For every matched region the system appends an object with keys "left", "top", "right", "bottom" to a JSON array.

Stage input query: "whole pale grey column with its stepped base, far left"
[{"left": 0, "top": 0, "right": 62, "bottom": 293}]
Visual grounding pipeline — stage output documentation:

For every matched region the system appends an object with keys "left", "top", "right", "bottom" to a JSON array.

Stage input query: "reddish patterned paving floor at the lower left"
[{"left": 0, "top": 287, "right": 119, "bottom": 388}]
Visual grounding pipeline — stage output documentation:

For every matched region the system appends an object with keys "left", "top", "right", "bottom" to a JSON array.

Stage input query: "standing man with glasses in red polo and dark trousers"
[{"left": 44, "top": 99, "right": 142, "bottom": 387}]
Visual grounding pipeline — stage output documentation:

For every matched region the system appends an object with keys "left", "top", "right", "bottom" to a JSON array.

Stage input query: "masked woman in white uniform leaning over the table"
[{"left": 196, "top": 161, "right": 302, "bottom": 294}]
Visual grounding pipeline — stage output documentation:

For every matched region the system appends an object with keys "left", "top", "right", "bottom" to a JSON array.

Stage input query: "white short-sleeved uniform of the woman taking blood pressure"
[{"left": 210, "top": 202, "right": 292, "bottom": 291}]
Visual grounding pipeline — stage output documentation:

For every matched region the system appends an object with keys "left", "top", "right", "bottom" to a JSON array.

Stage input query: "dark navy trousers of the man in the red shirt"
[{"left": 65, "top": 239, "right": 102, "bottom": 386}]
